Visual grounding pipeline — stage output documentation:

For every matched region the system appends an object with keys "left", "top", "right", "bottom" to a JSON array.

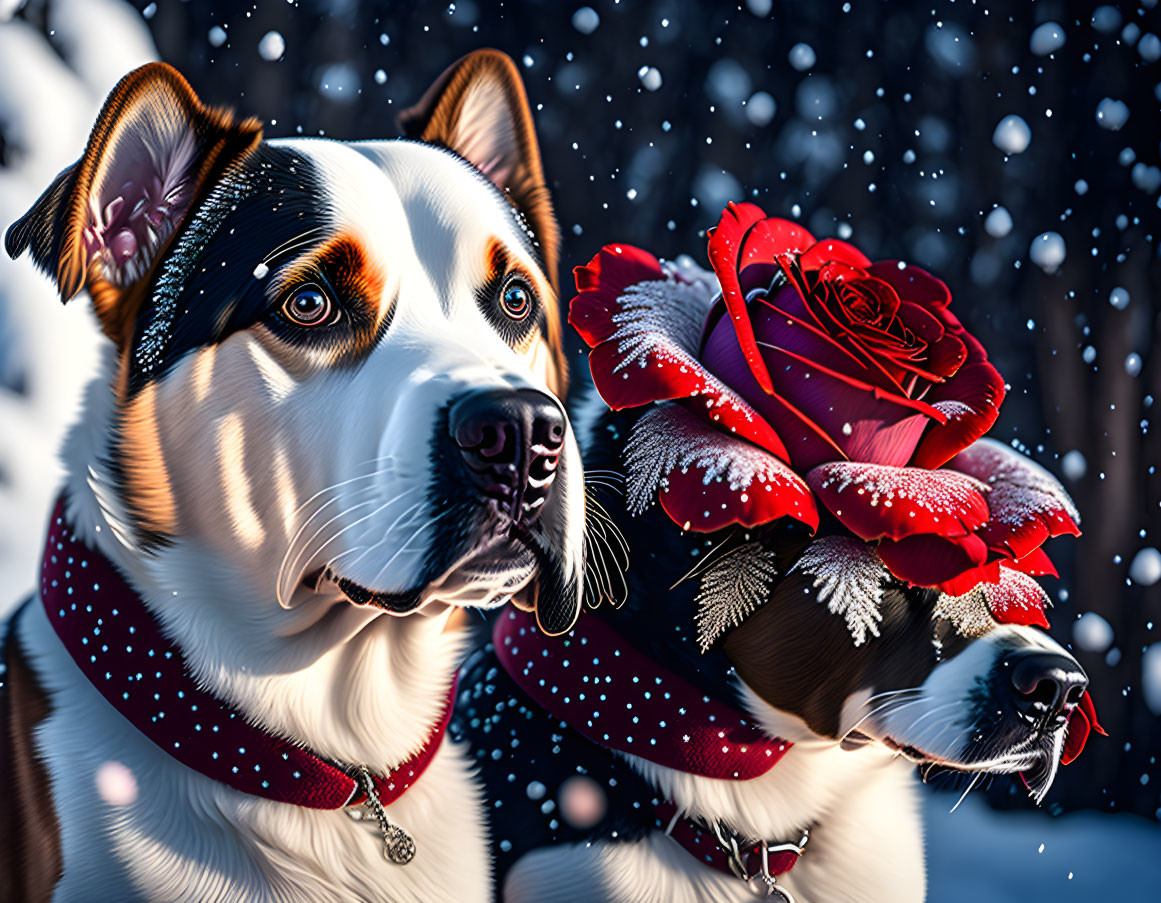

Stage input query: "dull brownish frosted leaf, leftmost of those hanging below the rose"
[{"left": 693, "top": 542, "right": 778, "bottom": 652}]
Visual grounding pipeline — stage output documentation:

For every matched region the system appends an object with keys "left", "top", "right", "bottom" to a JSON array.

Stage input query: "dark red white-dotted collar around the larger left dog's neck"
[{"left": 41, "top": 498, "right": 456, "bottom": 809}]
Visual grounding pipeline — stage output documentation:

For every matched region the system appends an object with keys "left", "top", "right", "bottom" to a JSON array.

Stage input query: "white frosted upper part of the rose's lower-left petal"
[{"left": 625, "top": 404, "right": 810, "bottom": 515}]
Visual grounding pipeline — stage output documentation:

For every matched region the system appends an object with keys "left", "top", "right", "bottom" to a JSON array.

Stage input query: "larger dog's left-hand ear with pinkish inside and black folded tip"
[{"left": 5, "top": 63, "right": 262, "bottom": 347}]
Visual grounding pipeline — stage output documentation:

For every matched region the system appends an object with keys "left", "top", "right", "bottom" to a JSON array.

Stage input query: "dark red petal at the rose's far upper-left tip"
[{"left": 569, "top": 245, "right": 665, "bottom": 347}]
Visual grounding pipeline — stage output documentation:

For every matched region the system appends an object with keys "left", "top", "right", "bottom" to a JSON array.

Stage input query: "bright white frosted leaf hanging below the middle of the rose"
[{"left": 791, "top": 536, "right": 889, "bottom": 646}]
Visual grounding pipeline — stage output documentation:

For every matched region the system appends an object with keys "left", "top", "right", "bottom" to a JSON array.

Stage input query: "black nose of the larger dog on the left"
[{"left": 448, "top": 389, "right": 565, "bottom": 522}]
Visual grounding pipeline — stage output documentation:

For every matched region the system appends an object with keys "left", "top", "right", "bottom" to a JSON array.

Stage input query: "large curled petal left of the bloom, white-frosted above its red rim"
[{"left": 589, "top": 266, "right": 789, "bottom": 458}]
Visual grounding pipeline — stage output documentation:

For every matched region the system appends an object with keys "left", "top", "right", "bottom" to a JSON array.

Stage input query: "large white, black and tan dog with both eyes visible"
[{"left": 0, "top": 51, "right": 584, "bottom": 903}]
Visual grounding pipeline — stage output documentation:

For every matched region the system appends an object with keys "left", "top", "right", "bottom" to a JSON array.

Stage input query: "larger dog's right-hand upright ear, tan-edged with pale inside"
[{"left": 399, "top": 50, "right": 560, "bottom": 291}]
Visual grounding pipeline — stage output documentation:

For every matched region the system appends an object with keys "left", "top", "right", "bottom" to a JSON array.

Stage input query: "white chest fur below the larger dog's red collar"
[{"left": 19, "top": 604, "right": 491, "bottom": 903}]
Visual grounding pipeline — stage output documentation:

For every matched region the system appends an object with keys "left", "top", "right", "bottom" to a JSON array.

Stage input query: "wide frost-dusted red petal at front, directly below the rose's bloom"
[{"left": 806, "top": 461, "right": 988, "bottom": 540}]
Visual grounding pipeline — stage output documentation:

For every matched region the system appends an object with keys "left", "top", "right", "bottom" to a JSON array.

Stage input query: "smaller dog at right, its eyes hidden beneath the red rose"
[{"left": 453, "top": 409, "right": 1087, "bottom": 903}]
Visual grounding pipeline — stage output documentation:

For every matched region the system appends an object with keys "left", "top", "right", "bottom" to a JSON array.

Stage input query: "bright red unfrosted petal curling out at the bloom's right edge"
[{"left": 911, "top": 359, "right": 1004, "bottom": 469}]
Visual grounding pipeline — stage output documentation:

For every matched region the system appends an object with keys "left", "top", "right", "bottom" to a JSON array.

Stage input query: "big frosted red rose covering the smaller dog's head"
[{"left": 569, "top": 204, "right": 1079, "bottom": 603}]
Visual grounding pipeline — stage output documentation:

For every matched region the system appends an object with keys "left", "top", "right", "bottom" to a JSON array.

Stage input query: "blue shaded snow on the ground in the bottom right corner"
[{"left": 924, "top": 793, "right": 1161, "bottom": 903}]
